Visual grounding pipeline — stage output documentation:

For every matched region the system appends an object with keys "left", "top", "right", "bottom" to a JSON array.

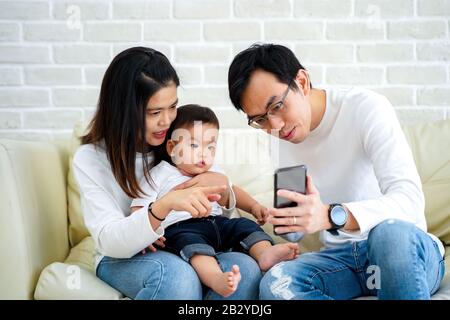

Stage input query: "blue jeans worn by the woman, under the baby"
[{"left": 97, "top": 250, "right": 262, "bottom": 300}]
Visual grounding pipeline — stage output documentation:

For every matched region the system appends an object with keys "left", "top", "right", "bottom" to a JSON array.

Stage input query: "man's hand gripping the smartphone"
[{"left": 267, "top": 176, "right": 331, "bottom": 233}]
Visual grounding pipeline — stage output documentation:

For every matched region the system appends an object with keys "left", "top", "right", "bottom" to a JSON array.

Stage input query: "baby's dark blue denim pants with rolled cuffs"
[{"left": 164, "top": 216, "right": 273, "bottom": 262}]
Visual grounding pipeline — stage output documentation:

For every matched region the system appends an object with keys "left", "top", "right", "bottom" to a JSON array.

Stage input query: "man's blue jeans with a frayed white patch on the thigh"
[{"left": 260, "top": 220, "right": 445, "bottom": 300}]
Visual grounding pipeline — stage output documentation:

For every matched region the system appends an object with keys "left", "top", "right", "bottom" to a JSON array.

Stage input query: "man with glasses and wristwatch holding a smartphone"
[{"left": 228, "top": 44, "right": 444, "bottom": 299}]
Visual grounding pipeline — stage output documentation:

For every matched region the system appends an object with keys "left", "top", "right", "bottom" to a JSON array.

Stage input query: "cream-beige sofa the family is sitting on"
[{"left": 0, "top": 120, "right": 450, "bottom": 299}]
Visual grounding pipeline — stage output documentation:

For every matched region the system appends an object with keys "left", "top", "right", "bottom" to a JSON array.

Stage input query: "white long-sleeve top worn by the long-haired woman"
[{"left": 73, "top": 144, "right": 236, "bottom": 267}]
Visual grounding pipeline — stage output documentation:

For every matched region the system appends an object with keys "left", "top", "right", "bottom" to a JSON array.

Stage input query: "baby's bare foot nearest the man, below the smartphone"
[{"left": 258, "top": 242, "right": 299, "bottom": 271}]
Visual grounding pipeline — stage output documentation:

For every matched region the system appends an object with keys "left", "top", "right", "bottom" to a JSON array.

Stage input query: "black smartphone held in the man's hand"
[{"left": 273, "top": 165, "right": 307, "bottom": 234}]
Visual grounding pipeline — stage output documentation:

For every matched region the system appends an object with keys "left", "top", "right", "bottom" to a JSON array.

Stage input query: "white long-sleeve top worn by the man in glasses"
[{"left": 278, "top": 88, "right": 444, "bottom": 254}]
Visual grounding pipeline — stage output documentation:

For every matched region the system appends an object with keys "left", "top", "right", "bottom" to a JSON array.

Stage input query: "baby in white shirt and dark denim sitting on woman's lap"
[{"left": 131, "top": 105, "right": 299, "bottom": 297}]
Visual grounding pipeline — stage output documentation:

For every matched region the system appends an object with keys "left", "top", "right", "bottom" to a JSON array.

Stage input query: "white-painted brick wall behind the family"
[{"left": 0, "top": 0, "right": 450, "bottom": 140}]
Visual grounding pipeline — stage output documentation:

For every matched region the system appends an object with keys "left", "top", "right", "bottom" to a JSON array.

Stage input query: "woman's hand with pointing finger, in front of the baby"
[{"left": 160, "top": 185, "right": 227, "bottom": 218}]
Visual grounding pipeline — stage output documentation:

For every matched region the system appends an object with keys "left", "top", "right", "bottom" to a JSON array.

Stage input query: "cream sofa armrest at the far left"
[{"left": 0, "top": 139, "right": 69, "bottom": 299}]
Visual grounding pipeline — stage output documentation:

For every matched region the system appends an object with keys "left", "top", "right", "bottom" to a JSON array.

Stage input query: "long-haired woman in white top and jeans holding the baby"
[{"left": 73, "top": 47, "right": 261, "bottom": 299}]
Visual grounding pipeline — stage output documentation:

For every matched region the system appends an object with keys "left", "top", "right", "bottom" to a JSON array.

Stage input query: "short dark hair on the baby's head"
[{"left": 154, "top": 104, "right": 220, "bottom": 165}]
